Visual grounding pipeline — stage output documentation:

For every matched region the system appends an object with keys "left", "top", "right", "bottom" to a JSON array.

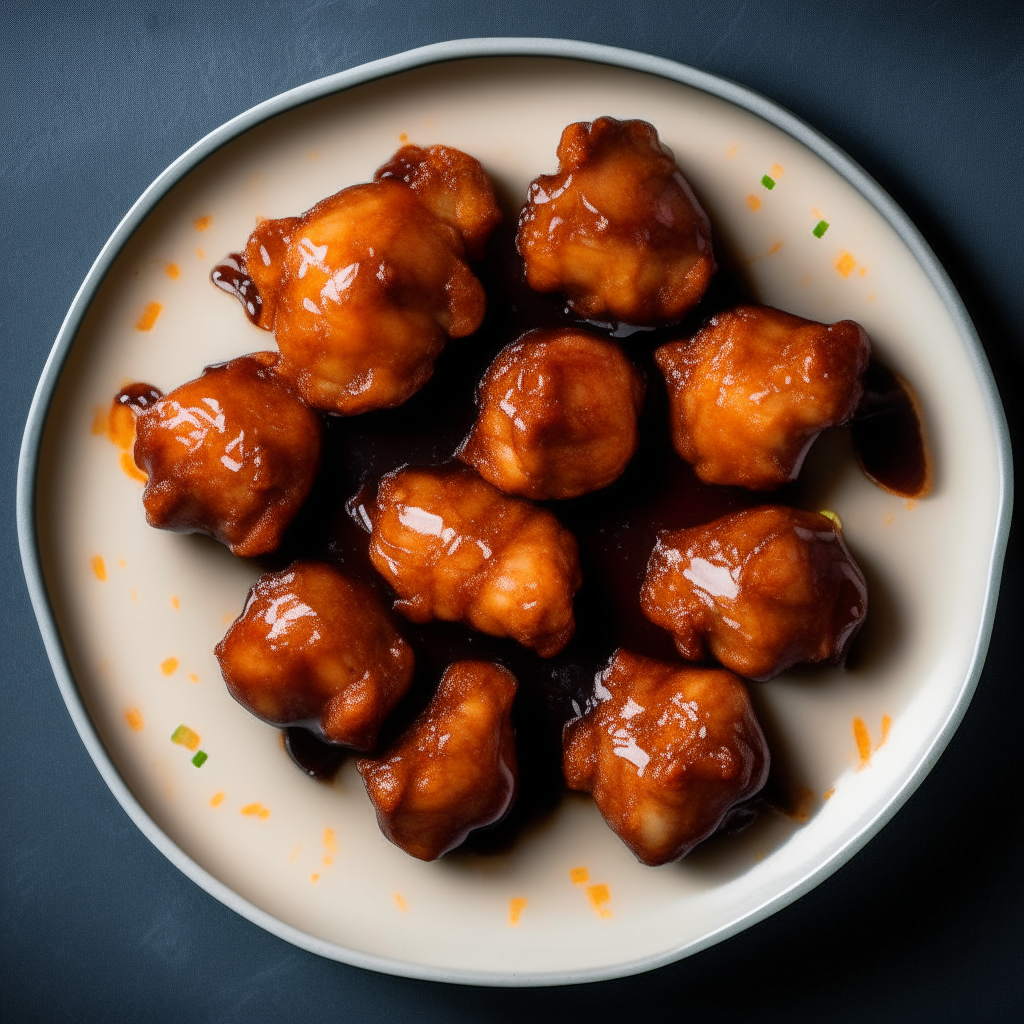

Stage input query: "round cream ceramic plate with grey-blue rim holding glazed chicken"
[{"left": 19, "top": 40, "right": 1011, "bottom": 984}]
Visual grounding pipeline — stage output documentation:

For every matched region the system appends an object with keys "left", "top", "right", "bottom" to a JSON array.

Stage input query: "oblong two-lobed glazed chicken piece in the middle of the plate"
[{"left": 370, "top": 468, "right": 582, "bottom": 657}]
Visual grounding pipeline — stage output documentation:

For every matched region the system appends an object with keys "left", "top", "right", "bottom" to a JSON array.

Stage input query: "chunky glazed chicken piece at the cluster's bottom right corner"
[{"left": 562, "top": 649, "right": 770, "bottom": 865}]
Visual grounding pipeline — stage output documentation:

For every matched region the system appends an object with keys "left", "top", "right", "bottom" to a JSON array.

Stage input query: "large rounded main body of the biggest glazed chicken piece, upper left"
[{"left": 274, "top": 181, "right": 486, "bottom": 416}]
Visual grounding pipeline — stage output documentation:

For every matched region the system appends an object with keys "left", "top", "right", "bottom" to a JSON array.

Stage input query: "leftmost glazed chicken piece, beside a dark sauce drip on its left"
[{"left": 134, "top": 352, "right": 323, "bottom": 557}]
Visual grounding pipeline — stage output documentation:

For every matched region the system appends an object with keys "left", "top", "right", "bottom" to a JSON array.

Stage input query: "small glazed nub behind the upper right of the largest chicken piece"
[{"left": 374, "top": 145, "right": 502, "bottom": 259}]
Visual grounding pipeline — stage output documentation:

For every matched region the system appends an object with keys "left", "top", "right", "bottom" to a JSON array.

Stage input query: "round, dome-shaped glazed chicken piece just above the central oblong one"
[{"left": 459, "top": 329, "right": 644, "bottom": 501}]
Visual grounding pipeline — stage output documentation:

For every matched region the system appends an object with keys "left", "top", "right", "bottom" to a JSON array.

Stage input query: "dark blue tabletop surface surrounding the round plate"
[{"left": 0, "top": 0, "right": 1024, "bottom": 1024}]
